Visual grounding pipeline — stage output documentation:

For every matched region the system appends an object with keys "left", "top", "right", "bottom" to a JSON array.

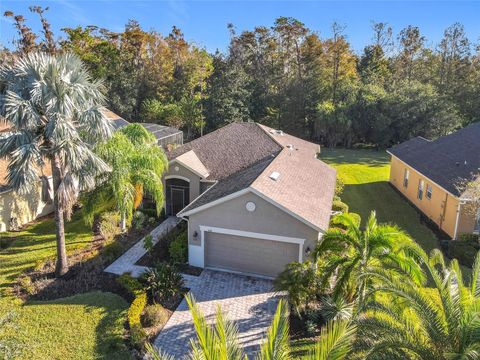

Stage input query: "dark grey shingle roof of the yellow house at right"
[{"left": 388, "top": 123, "right": 480, "bottom": 196}]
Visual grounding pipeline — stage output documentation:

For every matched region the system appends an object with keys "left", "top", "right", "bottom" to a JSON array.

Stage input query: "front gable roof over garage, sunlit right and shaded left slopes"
[{"left": 177, "top": 123, "right": 336, "bottom": 229}]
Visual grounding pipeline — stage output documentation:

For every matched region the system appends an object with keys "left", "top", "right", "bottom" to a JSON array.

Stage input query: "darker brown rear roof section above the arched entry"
[{"left": 167, "top": 123, "right": 282, "bottom": 180}]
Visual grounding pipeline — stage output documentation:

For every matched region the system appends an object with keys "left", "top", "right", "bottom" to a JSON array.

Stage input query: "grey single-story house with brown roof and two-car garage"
[{"left": 164, "top": 122, "right": 336, "bottom": 277}]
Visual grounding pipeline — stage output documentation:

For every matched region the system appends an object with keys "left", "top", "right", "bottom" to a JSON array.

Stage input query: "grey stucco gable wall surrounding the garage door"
[{"left": 188, "top": 193, "right": 319, "bottom": 258}]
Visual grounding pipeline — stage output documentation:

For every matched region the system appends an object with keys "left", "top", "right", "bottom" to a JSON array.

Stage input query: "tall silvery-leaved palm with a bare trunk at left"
[{"left": 0, "top": 53, "right": 112, "bottom": 276}]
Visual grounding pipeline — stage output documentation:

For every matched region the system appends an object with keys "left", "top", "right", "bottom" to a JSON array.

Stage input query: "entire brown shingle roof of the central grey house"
[{"left": 174, "top": 123, "right": 336, "bottom": 230}]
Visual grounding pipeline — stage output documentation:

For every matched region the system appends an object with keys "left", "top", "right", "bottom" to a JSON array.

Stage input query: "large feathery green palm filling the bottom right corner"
[{"left": 358, "top": 250, "right": 480, "bottom": 360}]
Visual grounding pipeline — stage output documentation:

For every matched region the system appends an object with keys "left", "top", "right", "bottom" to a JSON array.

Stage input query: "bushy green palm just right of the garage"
[{"left": 313, "top": 211, "right": 425, "bottom": 309}]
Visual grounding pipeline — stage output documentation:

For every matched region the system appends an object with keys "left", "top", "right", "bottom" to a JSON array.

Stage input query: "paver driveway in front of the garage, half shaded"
[{"left": 154, "top": 270, "right": 279, "bottom": 359}]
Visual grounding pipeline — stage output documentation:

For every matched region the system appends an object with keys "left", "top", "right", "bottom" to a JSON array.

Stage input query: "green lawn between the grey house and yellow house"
[{"left": 320, "top": 149, "right": 438, "bottom": 252}]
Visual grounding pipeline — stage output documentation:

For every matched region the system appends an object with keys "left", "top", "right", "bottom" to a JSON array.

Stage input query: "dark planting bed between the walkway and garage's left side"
[{"left": 136, "top": 223, "right": 203, "bottom": 276}]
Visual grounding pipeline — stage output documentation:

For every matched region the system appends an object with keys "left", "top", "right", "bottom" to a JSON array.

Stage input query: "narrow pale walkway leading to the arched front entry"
[{"left": 105, "top": 216, "right": 182, "bottom": 278}]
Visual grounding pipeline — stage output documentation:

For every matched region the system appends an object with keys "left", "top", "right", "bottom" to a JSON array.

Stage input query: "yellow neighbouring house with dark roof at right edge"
[{"left": 387, "top": 123, "right": 480, "bottom": 239}]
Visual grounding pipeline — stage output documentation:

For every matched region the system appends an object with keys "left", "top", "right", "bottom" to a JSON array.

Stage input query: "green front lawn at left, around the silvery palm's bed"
[{"left": 0, "top": 213, "right": 130, "bottom": 359}]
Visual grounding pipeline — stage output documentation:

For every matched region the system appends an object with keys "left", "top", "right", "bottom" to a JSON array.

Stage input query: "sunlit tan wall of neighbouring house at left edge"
[{"left": 0, "top": 180, "right": 53, "bottom": 232}]
